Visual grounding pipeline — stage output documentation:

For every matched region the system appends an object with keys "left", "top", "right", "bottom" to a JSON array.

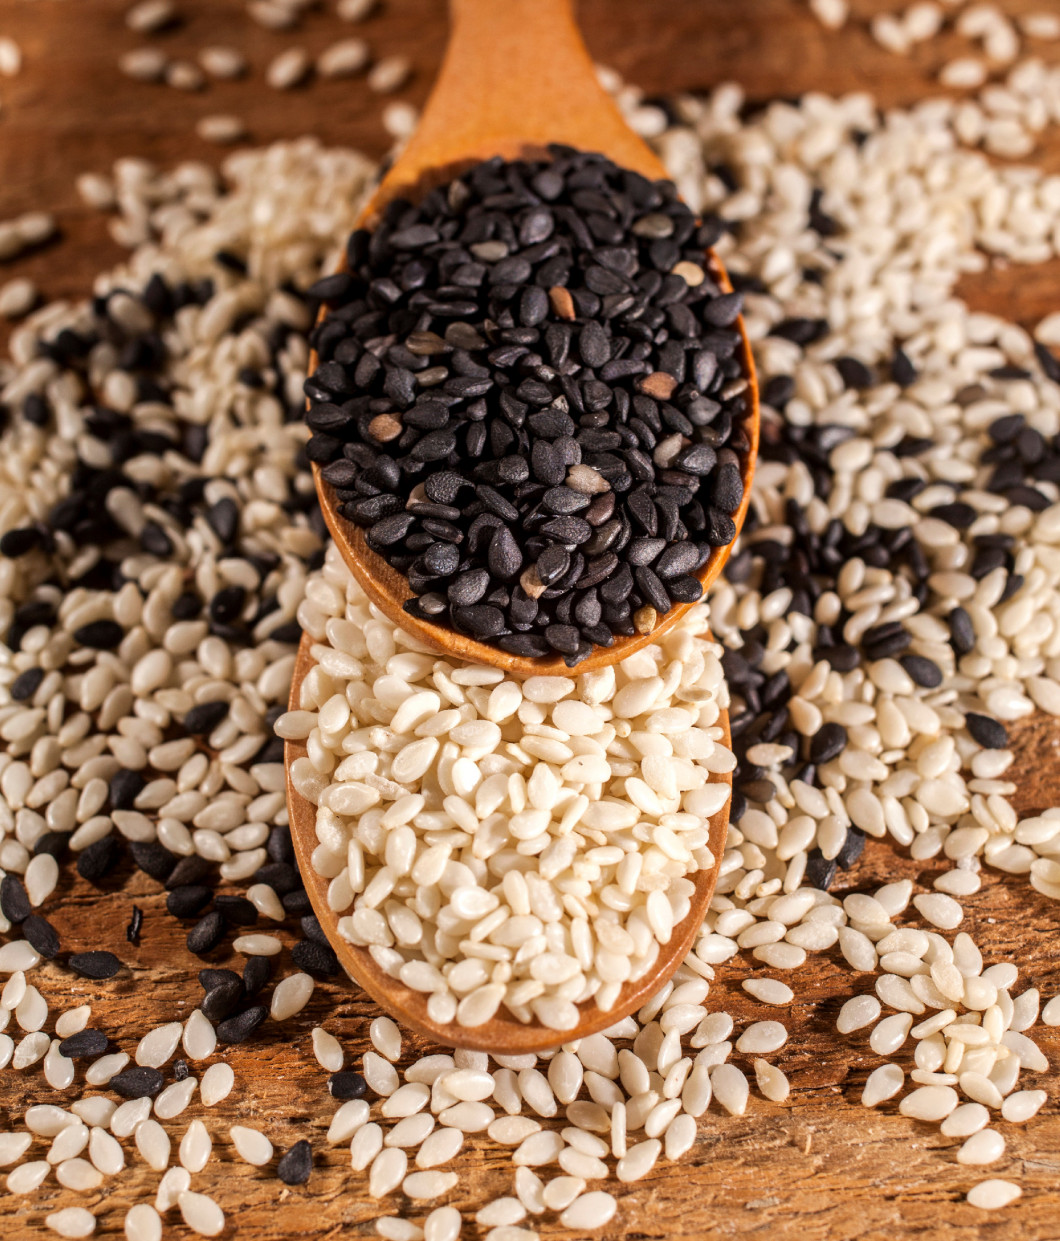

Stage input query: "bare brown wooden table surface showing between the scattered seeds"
[{"left": 0, "top": 0, "right": 1060, "bottom": 1241}]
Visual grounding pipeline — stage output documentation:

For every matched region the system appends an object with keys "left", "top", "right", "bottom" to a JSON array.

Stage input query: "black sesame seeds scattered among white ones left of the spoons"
[{"left": 0, "top": 264, "right": 339, "bottom": 1077}]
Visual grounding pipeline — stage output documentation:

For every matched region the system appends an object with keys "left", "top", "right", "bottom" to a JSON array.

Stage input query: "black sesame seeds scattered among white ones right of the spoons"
[{"left": 722, "top": 392, "right": 1037, "bottom": 890}]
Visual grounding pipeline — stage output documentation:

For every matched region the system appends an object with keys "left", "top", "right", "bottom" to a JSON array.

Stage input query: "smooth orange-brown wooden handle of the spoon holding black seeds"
[{"left": 372, "top": 0, "right": 665, "bottom": 208}]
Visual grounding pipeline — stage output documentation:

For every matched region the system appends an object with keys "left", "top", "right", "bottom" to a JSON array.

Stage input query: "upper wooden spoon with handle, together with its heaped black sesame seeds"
[{"left": 307, "top": 0, "right": 758, "bottom": 678}]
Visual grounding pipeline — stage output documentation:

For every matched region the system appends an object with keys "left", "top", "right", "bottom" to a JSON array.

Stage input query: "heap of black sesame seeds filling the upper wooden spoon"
[{"left": 305, "top": 148, "right": 751, "bottom": 665}]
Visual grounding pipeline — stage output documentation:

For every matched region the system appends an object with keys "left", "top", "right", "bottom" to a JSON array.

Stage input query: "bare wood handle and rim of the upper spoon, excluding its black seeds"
[{"left": 309, "top": 0, "right": 758, "bottom": 676}]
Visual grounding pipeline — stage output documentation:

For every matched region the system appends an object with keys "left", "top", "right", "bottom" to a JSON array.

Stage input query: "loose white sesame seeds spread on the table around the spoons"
[{"left": 0, "top": 7, "right": 1060, "bottom": 1241}]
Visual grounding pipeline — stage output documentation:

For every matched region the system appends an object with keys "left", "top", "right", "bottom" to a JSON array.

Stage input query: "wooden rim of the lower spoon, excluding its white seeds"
[{"left": 284, "top": 634, "right": 732, "bottom": 1055}]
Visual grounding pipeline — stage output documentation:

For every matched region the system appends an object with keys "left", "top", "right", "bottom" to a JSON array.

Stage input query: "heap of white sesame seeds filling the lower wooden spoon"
[{"left": 276, "top": 547, "right": 735, "bottom": 1034}]
